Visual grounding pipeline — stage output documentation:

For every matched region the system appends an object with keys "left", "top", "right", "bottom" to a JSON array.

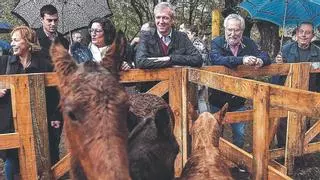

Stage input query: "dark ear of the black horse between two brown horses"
[{"left": 154, "top": 107, "right": 171, "bottom": 136}]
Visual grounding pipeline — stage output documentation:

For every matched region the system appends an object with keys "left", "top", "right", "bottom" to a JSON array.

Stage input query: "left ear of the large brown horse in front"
[{"left": 50, "top": 41, "right": 78, "bottom": 76}]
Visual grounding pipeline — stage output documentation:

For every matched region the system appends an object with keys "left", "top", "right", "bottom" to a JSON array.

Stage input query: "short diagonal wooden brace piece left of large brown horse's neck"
[{"left": 51, "top": 153, "right": 71, "bottom": 179}]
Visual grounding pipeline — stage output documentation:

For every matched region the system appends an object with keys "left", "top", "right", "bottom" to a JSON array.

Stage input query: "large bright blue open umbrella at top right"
[{"left": 239, "top": 0, "right": 320, "bottom": 48}]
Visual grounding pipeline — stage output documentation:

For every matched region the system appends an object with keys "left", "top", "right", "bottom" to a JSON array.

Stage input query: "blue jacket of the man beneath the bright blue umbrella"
[{"left": 271, "top": 42, "right": 320, "bottom": 92}]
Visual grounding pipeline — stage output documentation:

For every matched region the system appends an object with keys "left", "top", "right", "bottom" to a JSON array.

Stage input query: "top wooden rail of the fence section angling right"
[{"left": 188, "top": 68, "right": 320, "bottom": 117}]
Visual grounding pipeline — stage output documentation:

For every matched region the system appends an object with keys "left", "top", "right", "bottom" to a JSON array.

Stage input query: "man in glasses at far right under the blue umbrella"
[{"left": 272, "top": 22, "right": 320, "bottom": 147}]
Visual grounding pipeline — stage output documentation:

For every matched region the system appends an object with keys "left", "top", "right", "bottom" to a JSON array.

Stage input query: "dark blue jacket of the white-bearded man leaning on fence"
[{"left": 209, "top": 36, "right": 271, "bottom": 111}]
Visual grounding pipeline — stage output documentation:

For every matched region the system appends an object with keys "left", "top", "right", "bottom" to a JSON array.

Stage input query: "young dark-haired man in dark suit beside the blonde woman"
[{"left": 36, "top": 4, "right": 69, "bottom": 165}]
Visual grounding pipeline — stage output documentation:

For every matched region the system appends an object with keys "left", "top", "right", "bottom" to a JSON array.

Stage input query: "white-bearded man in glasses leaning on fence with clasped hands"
[{"left": 209, "top": 14, "right": 271, "bottom": 171}]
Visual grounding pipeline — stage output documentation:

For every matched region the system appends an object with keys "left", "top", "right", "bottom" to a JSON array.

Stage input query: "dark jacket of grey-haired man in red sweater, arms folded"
[{"left": 136, "top": 30, "right": 202, "bottom": 69}]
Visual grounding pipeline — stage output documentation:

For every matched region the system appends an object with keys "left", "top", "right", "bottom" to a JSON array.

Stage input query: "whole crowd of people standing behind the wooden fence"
[{"left": 0, "top": 2, "right": 320, "bottom": 180}]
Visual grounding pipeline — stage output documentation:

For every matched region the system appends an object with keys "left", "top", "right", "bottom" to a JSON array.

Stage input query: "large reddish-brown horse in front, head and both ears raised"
[{"left": 51, "top": 33, "right": 130, "bottom": 180}]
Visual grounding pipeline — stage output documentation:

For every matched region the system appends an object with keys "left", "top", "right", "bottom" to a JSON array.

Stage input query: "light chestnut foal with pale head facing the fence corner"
[{"left": 180, "top": 105, "right": 233, "bottom": 180}]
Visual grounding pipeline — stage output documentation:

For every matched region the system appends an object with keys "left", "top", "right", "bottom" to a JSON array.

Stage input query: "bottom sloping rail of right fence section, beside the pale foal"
[{"left": 219, "top": 138, "right": 291, "bottom": 180}]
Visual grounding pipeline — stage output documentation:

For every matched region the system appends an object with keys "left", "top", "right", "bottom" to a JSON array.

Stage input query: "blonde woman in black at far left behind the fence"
[{"left": 0, "top": 26, "right": 52, "bottom": 180}]
